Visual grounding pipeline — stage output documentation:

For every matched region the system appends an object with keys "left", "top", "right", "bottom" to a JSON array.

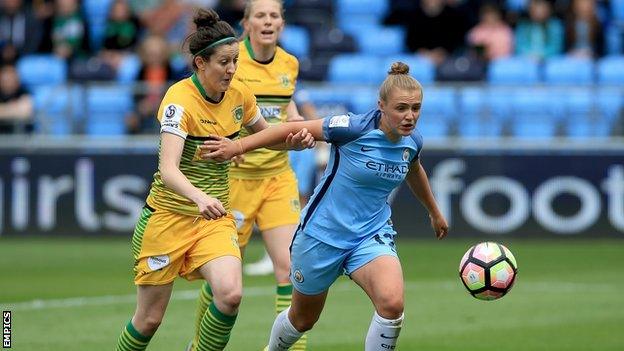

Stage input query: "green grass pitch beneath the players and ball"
[{"left": 0, "top": 238, "right": 624, "bottom": 351}]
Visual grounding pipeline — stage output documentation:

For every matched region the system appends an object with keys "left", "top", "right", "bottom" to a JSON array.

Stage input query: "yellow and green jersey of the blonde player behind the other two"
[{"left": 230, "top": 38, "right": 299, "bottom": 179}]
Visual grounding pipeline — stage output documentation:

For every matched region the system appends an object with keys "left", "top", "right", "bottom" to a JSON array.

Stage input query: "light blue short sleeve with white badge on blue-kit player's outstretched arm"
[{"left": 323, "top": 113, "right": 375, "bottom": 145}]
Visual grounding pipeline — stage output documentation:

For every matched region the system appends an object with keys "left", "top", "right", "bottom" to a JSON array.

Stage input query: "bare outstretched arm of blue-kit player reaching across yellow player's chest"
[{"left": 200, "top": 119, "right": 324, "bottom": 162}]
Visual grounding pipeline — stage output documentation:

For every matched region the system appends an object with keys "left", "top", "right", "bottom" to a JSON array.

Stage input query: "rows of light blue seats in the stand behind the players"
[{"left": 2, "top": 0, "right": 624, "bottom": 138}]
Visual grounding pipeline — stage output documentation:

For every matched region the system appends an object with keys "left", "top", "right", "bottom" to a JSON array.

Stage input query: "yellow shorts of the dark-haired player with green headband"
[{"left": 132, "top": 205, "right": 241, "bottom": 285}]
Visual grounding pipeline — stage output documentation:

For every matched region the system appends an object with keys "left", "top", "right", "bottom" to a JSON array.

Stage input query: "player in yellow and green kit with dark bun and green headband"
[{"left": 116, "top": 10, "right": 311, "bottom": 351}]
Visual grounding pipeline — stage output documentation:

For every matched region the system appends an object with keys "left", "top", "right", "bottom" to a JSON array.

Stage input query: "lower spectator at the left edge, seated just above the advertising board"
[{"left": 0, "top": 65, "right": 33, "bottom": 134}]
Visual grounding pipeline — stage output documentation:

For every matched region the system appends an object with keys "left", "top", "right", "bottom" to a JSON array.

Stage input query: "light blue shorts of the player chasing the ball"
[{"left": 290, "top": 230, "right": 398, "bottom": 295}]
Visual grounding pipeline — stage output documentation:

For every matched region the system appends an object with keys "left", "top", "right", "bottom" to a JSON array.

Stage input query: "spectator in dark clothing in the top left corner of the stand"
[{"left": 0, "top": 0, "right": 43, "bottom": 63}]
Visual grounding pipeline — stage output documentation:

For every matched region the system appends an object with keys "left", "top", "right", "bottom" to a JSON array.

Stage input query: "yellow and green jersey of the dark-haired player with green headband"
[{"left": 147, "top": 74, "right": 259, "bottom": 216}]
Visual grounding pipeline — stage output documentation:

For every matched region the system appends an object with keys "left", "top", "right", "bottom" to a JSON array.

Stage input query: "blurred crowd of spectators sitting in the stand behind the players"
[{"left": 0, "top": 0, "right": 624, "bottom": 134}]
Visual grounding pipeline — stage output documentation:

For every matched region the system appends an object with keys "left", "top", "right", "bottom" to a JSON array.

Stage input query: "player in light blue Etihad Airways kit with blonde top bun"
[{"left": 201, "top": 62, "right": 448, "bottom": 351}]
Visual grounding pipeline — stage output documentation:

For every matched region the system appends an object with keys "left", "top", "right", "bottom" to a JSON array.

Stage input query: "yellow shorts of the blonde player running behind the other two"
[{"left": 230, "top": 170, "right": 301, "bottom": 247}]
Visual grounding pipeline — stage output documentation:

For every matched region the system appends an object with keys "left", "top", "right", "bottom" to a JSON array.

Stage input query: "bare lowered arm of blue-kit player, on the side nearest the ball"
[{"left": 406, "top": 160, "right": 448, "bottom": 239}]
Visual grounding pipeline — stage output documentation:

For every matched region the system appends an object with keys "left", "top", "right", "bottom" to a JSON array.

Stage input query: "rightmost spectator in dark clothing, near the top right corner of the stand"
[{"left": 565, "top": 0, "right": 604, "bottom": 58}]
